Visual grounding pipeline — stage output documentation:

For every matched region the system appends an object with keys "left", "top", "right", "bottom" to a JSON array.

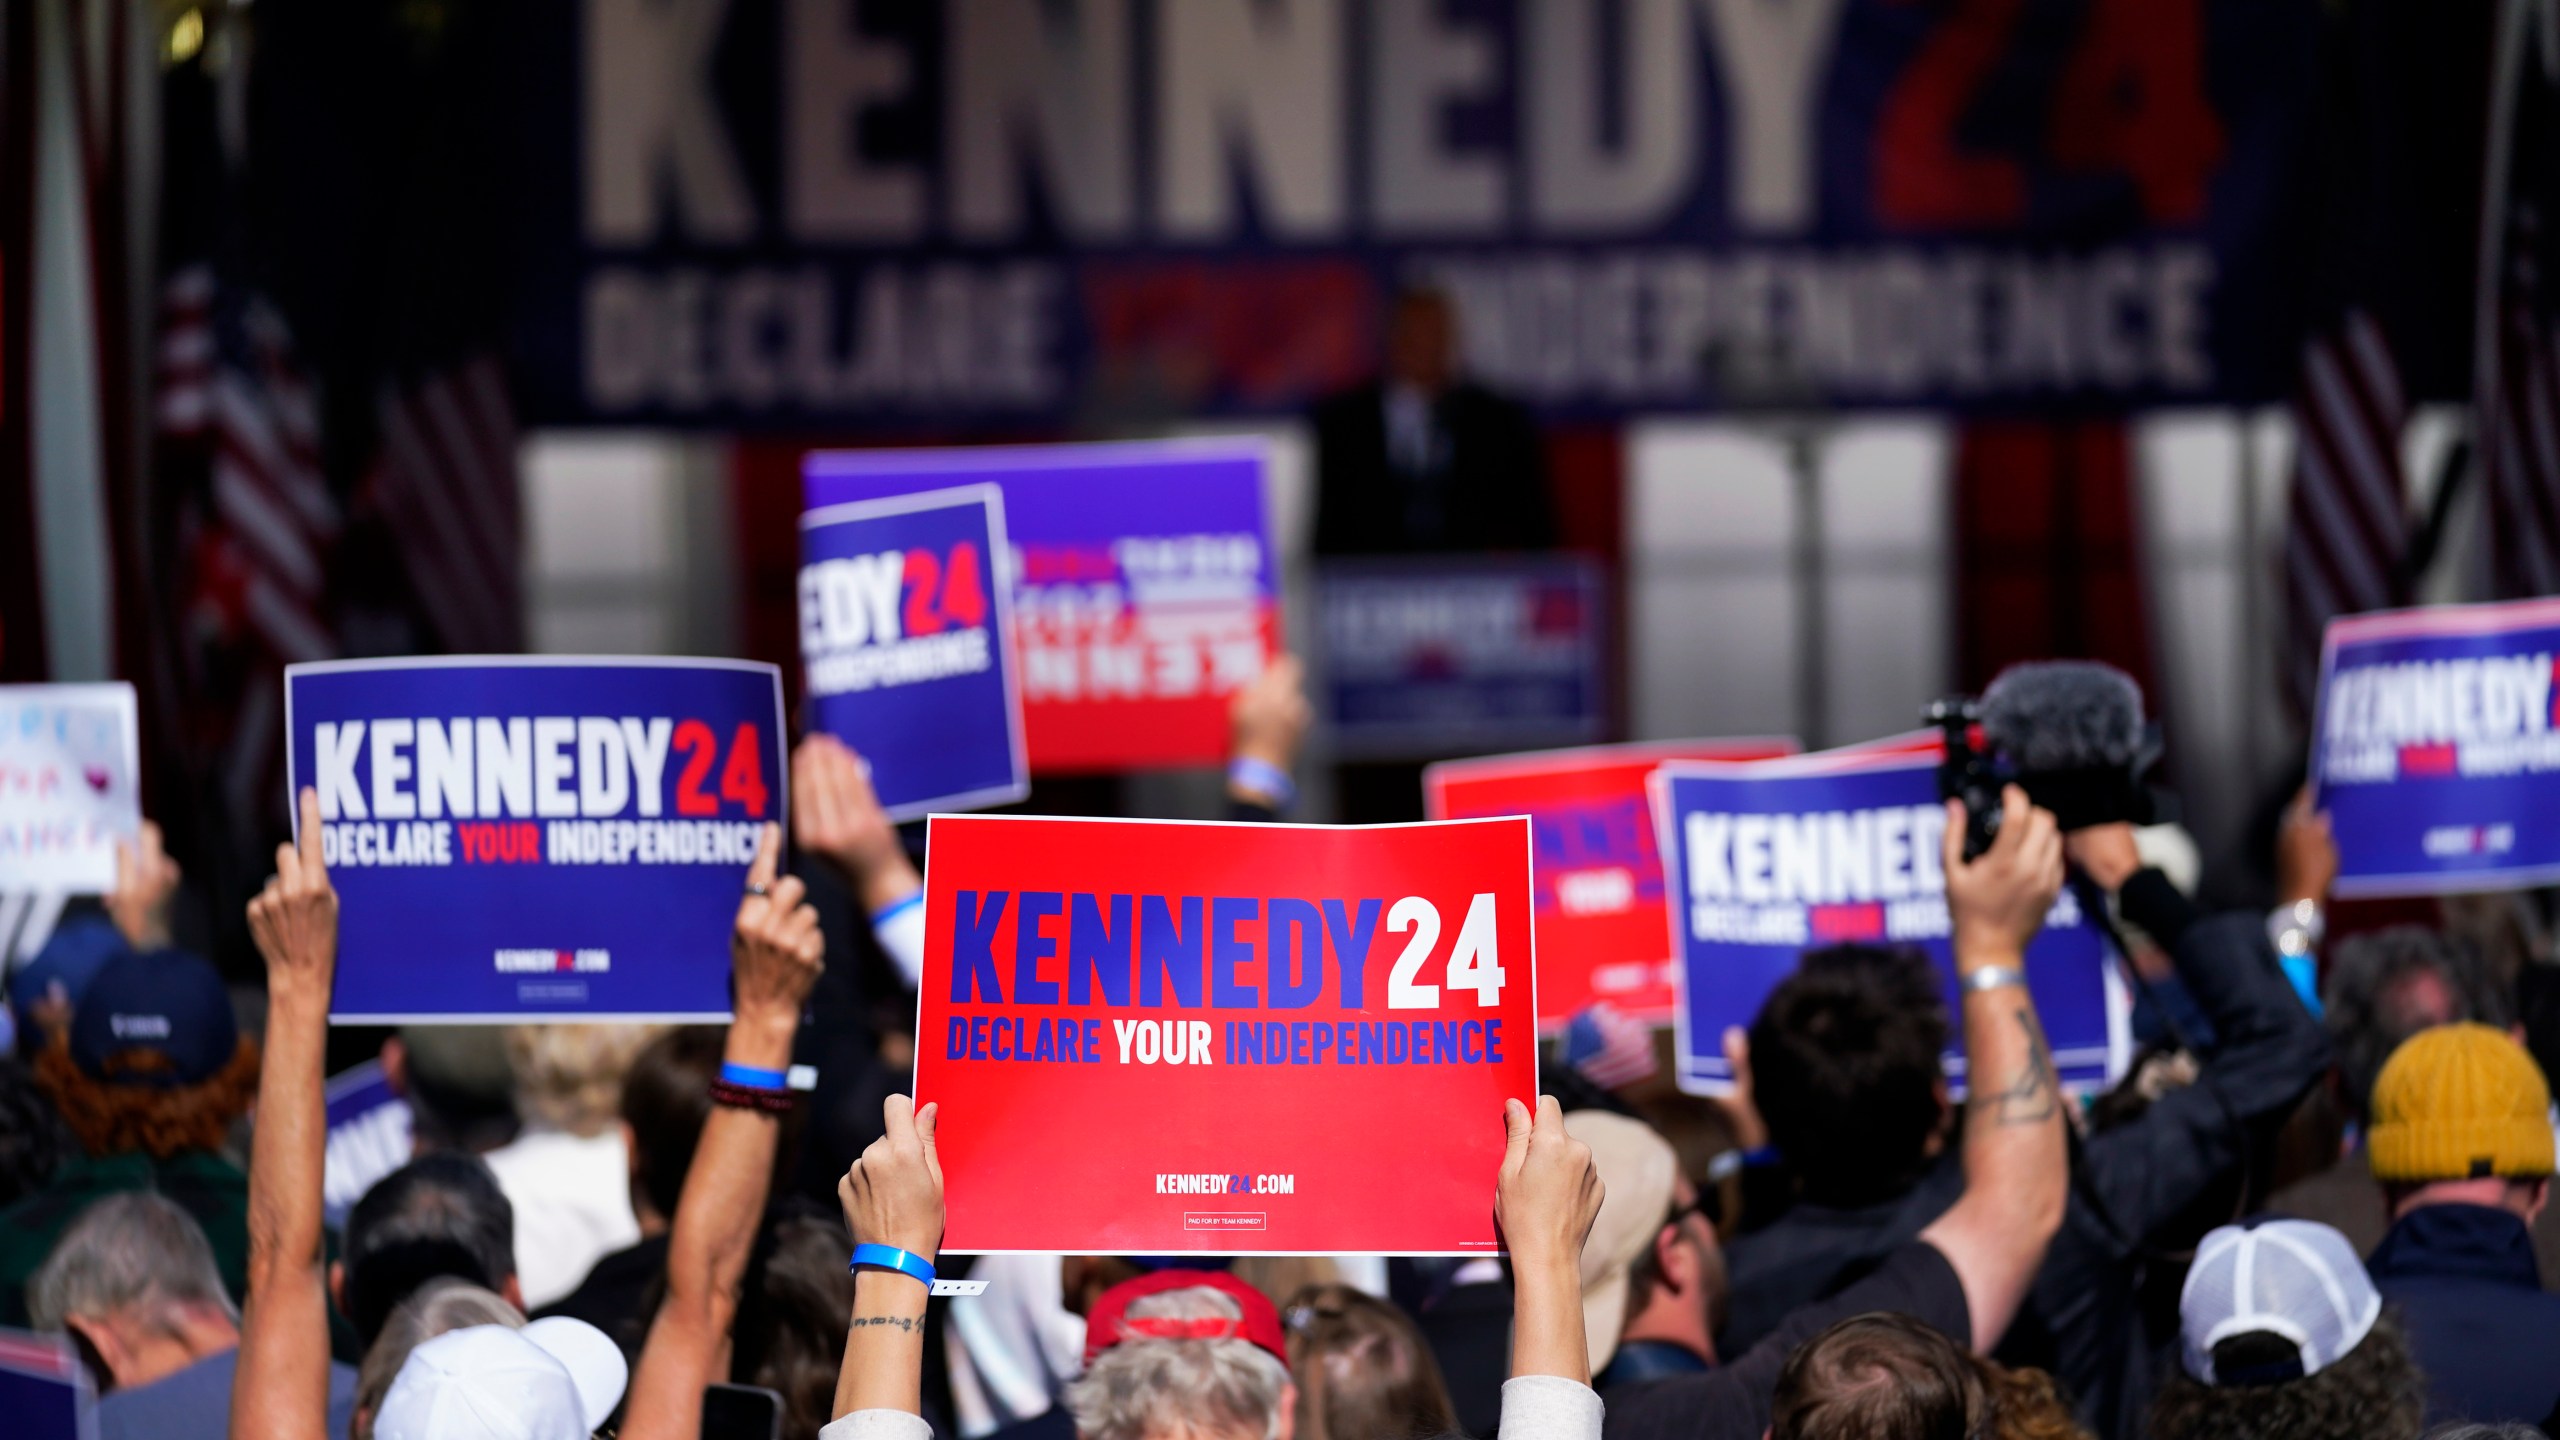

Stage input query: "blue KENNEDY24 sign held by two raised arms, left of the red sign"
[{"left": 284, "top": 656, "right": 788, "bottom": 1025}]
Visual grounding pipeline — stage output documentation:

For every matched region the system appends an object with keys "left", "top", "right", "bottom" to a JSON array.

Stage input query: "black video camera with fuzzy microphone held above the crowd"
[{"left": 1928, "top": 661, "right": 2176, "bottom": 861}]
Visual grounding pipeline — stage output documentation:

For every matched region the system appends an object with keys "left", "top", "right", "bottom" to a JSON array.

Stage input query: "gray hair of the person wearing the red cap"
[{"left": 1068, "top": 1286, "right": 1290, "bottom": 1440}]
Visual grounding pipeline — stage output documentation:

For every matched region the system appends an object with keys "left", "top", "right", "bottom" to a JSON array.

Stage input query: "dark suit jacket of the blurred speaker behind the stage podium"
[{"left": 1313, "top": 384, "right": 1556, "bottom": 556}]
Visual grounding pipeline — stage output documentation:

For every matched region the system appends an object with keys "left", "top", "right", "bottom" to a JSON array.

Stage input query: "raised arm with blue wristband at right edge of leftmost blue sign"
[{"left": 622, "top": 825, "right": 824, "bottom": 1440}]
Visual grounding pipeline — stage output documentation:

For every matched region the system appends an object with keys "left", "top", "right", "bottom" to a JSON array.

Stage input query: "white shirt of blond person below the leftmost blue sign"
[{"left": 486, "top": 1125, "right": 640, "bottom": 1312}]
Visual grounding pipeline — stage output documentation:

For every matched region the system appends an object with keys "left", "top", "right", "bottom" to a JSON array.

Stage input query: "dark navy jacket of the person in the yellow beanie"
[{"left": 2365, "top": 1204, "right": 2560, "bottom": 1427}]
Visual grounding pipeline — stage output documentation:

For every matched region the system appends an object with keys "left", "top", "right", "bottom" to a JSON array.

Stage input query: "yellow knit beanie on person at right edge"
[{"left": 2365, "top": 1022, "right": 2552, "bottom": 1184}]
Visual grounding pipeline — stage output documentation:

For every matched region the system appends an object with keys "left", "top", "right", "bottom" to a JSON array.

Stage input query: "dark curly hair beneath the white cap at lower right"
[{"left": 2150, "top": 1312, "right": 2427, "bottom": 1440}]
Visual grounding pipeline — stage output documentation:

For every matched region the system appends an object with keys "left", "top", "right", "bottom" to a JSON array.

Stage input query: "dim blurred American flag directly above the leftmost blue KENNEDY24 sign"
[{"left": 369, "top": 354, "right": 525, "bottom": 653}]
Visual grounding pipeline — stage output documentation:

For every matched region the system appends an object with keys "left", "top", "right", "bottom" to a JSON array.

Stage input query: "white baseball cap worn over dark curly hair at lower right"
[{"left": 2179, "top": 1220, "right": 2383, "bottom": 1386}]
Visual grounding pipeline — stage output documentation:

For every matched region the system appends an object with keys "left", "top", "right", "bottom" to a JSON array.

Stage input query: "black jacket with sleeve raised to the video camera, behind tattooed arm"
[{"left": 1715, "top": 871, "right": 2330, "bottom": 1440}]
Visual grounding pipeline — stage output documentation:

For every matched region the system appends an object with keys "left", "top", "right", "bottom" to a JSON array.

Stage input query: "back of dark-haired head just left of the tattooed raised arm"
[{"left": 1751, "top": 945, "right": 1948, "bottom": 1207}]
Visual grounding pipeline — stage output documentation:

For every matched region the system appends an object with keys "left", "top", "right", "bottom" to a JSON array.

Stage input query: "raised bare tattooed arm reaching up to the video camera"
[{"left": 1920, "top": 787, "right": 2071, "bottom": 1350}]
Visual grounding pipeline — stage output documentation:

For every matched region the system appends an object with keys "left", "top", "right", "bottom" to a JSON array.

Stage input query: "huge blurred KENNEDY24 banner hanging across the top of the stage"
[{"left": 509, "top": 0, "right": 2322, "bottom": 433}]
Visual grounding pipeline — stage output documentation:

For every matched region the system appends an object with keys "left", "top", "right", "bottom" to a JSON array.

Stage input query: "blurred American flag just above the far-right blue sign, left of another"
[{"left": 2284, "top": 307, "right": 2409, "bottom": 715}]
